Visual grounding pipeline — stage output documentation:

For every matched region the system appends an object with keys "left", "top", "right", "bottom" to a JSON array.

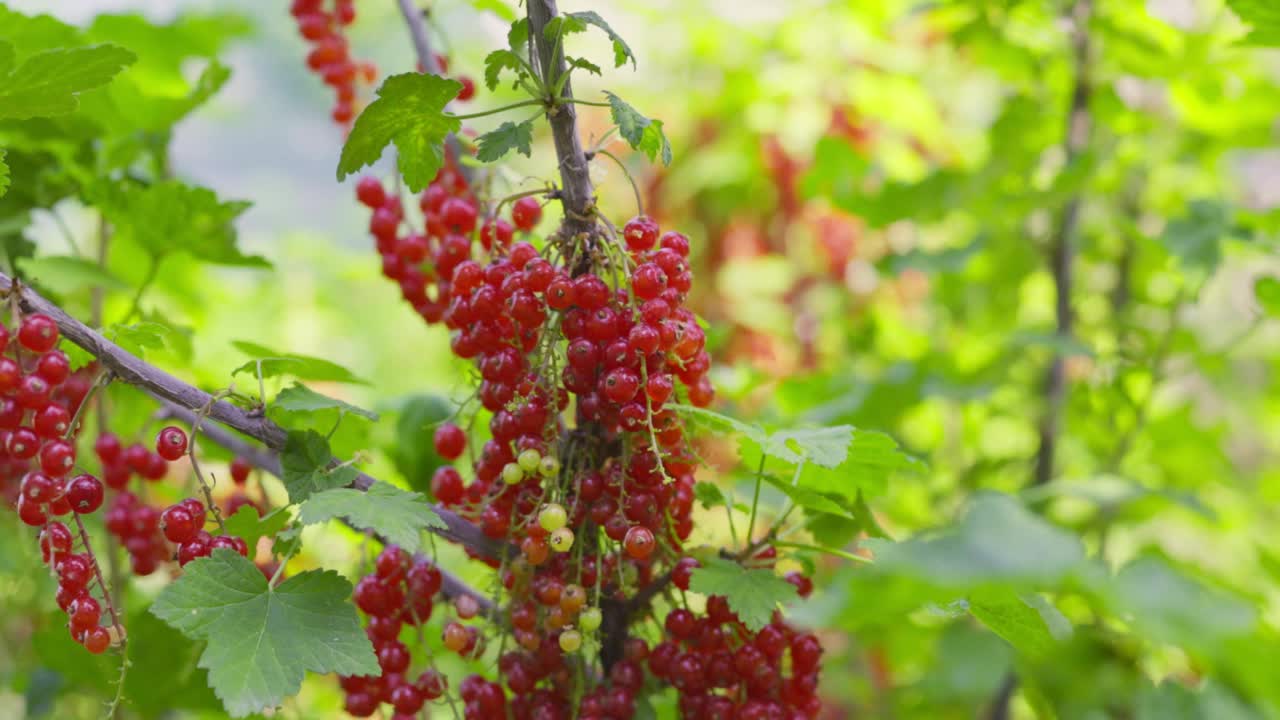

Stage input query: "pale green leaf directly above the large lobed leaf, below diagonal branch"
[{"left": 298, "top": 482, "right": 445, "bottom": 552}]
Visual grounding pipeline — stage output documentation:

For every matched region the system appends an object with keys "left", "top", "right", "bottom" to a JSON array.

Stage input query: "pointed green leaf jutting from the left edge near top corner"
[{"left": 0, "top": 44, "right": 137, "bottom": 120}]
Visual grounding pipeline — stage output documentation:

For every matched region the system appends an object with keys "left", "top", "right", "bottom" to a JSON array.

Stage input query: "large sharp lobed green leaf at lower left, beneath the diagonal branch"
[{"left": 151, "top": 548, "right": 379, "bottom": 717}]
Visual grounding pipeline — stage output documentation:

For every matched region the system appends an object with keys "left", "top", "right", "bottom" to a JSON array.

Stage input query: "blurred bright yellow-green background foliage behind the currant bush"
[{"left": 0, "top": 0, "right": 1280, "bottom": 720}]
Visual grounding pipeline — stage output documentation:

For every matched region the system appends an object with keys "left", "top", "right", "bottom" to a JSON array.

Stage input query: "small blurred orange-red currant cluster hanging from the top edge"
[{"left": 289, "top": 0, "right": 378, "bottom": 126}]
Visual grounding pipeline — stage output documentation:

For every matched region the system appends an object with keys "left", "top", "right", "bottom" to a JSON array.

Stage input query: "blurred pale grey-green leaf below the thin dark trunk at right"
[{"left": 868, "top": 493, "right": 1084, "bottom": 589}]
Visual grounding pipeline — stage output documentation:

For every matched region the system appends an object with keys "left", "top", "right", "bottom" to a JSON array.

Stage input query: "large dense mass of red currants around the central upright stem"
[{"left": 356, "top": 168, "right": 820, "bottom": 719}]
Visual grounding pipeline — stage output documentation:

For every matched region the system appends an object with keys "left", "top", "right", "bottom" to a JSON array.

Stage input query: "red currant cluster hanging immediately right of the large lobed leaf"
[{"left": 339, "top": 546, "right": 450, "bottom": 720}]
